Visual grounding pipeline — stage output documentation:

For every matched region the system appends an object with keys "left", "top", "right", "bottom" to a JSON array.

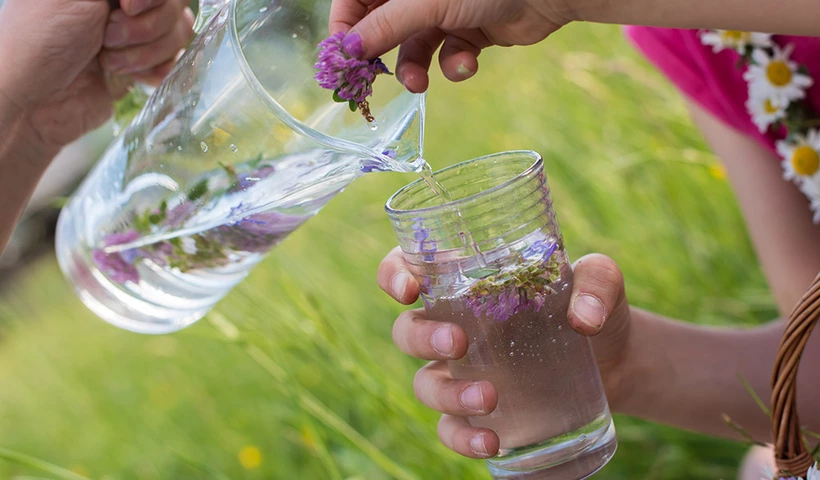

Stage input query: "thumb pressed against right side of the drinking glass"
[{"left": 567, "top": 254, "right": 628, "bottom": 336}]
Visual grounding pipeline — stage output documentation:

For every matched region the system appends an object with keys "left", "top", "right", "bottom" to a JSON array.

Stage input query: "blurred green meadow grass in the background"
[{"left": 0, "top": 25, "right": 775, "bottom": 480}]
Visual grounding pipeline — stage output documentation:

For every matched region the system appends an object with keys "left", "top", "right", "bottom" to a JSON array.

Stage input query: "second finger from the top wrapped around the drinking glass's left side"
[{"left": 393, "top": 308, "right": 468, "bottom": 360}]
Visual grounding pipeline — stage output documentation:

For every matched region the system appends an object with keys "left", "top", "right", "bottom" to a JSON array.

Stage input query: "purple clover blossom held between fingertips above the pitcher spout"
[{"left": 314, "top": 32, "right": 390, "bottom": 122}]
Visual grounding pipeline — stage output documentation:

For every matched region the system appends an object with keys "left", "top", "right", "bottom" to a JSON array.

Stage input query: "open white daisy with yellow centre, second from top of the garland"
[{"left": 743, "top": 44, "right": 813, "bottom": 105}]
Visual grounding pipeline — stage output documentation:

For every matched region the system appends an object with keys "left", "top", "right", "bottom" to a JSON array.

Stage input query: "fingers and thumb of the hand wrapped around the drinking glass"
[{"left": 378, "top": 248, "right": 631, "bottom": 458}]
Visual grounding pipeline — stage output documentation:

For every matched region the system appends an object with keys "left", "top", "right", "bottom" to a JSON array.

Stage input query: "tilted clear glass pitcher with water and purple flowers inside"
[{"left": 56, "top": 0, "right": 424, "bottom": 333}]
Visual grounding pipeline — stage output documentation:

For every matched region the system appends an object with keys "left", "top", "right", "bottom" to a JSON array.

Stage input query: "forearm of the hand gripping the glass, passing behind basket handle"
[{"left": 619, "top": 309, "right": 820, "bottom": 441}]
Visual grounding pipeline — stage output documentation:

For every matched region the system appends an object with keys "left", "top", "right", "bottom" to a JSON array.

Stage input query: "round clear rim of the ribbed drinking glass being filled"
[{"left": 384, "top": 150, "right": 544, "bottom": 217}]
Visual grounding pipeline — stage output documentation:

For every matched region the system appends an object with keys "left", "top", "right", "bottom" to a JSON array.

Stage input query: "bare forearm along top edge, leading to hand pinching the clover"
[{"left": 566, "top": 0, "right": 820, "bottom": 36}]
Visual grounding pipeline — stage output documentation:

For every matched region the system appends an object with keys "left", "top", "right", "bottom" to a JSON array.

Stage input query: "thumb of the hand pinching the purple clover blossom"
[{"left": 350, "top": 0, "right": 448, "bottom": 58}]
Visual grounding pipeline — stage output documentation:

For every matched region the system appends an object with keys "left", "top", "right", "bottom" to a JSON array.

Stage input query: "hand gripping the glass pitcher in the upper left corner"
[{"left": 0, "top": 0, "right": 193, "bottom": 152}]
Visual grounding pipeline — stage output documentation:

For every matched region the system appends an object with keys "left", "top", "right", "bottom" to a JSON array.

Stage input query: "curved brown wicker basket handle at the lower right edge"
[{"left": 771, "top": 275, "right": 820, "bottom": 478}]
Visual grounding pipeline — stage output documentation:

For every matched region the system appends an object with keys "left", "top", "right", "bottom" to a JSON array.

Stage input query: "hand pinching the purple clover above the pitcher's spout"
[{"left": 330, "top": 0, "right": 577, "bottom": 93}]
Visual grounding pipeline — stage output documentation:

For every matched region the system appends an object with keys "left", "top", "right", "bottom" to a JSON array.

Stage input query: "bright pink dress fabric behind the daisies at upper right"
[{"left": 625, "top": 27, "right": 820, "bottom": 152}]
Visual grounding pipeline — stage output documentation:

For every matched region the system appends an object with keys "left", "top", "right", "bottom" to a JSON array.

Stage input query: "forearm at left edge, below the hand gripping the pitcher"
[{"left": 0, "top": 88, "right": 57, "bottom": 252}]
